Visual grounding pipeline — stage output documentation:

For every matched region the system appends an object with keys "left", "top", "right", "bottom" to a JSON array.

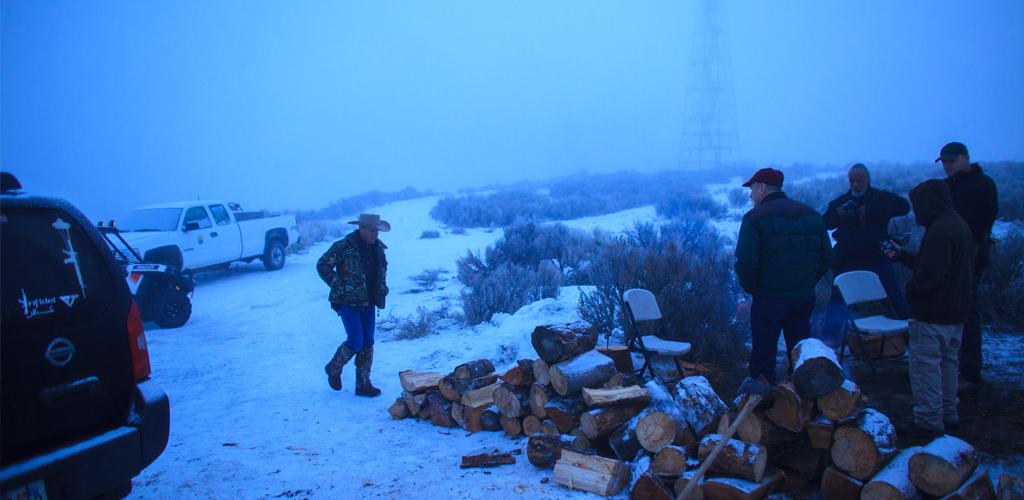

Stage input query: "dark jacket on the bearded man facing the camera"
[{"left": 823, "top": 188, "right": 910, "bottom": 265}]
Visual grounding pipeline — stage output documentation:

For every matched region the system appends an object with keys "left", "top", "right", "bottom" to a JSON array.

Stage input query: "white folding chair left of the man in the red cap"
[{"left": 623, "top": 288, "right": 690, "bottom": 379}]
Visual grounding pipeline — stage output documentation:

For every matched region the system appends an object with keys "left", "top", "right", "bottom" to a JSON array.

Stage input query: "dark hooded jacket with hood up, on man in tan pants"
[{"left": 900, "top": 179, "right": 974, "bottom": 325}]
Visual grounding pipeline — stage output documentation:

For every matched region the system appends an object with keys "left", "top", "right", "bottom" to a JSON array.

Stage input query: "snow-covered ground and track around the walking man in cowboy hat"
[{"left": 131, "top": 198, "right": 655, "bottom": 498}]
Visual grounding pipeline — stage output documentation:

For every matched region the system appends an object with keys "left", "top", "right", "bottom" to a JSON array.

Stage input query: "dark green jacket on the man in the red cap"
[{"left": 735, "top": 192, "right": 831, "bottom": 298}]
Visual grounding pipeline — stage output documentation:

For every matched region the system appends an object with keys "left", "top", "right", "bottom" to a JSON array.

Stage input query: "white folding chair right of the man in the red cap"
[{"left": 834, "top": 270, "right": 909, "bottom": 378}]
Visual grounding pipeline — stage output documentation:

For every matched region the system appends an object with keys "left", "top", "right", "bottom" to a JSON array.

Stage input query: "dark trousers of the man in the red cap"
[{"left": 750, "top": 296, "right": 814, "bottom": 384}]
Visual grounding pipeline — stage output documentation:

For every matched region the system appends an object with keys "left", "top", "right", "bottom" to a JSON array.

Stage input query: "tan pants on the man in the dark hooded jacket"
[{"left": 909, "top": 321, "right": 964, "bottom": 430}]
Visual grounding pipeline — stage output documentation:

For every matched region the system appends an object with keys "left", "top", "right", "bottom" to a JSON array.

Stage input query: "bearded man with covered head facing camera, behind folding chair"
[{"left": 822, "top": 163, "right": 910, "bottom": 344}]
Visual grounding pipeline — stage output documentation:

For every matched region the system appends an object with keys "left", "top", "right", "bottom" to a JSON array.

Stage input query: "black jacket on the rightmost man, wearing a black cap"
[{"left": 946, "top": 163, "right": 999, "bottom": 268}]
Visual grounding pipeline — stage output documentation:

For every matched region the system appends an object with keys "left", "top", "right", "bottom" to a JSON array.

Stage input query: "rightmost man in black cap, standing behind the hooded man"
[{"left": 935, "top": 142, "right": 999, "bottom": 385}]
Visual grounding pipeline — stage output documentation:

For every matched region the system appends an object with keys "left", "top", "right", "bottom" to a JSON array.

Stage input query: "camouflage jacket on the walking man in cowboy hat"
[{"left": 316, "top": 230, "right": 388, "bottom": 310}]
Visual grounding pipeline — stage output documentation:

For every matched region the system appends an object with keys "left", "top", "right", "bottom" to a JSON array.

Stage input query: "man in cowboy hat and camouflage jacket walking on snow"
[{"left": 316, "top": 213, "right": 391, "bottom": 398}]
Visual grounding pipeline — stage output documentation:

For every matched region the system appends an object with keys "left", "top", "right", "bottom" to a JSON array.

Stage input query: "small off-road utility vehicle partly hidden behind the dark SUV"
[{"left": 98, "top": 225, "right": 196, "bottom": 328}]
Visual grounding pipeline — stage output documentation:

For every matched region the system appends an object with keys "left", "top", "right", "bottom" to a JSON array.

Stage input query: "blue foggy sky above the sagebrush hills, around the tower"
[{"left": 0, "top": 0, "right": 1024, "bottom": 218}]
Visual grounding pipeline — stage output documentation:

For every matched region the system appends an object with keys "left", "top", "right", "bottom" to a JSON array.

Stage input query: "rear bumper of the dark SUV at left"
[{"left": 0, "top": 380, "right": 170, "bottom": 498}]
